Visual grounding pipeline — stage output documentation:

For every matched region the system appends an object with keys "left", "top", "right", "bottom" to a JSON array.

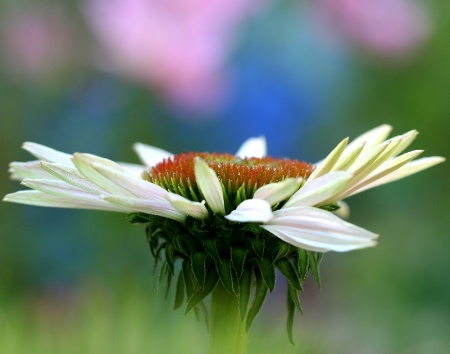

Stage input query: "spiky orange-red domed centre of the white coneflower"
[{"left": 145, "top": 152, "right": 314, "bottom": 201}]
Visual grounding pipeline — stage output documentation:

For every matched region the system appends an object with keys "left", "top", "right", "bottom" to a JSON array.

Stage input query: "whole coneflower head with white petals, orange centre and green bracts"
[{"left": 4, "top": 125, "right": 444, "bottom": 336}]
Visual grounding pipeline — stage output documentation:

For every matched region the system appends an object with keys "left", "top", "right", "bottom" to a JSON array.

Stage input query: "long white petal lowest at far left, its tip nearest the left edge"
[{"left": 3, "top": 191, "right": 129, "bottom": 213}]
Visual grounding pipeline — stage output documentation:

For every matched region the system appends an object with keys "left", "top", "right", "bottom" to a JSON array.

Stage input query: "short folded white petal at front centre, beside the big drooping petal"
[{"left": 225, "top": 199, "right": 273, "bottom": 223}]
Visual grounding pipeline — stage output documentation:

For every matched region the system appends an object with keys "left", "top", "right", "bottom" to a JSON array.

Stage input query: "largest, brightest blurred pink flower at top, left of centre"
[{"left": 87, "top": 0, "right": 260, "bottom": 109}]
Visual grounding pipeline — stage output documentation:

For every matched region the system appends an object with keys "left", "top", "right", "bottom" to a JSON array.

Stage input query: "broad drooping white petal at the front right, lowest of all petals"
[{"left": 261, "top": 207, "right": 378, "bottom": 252}]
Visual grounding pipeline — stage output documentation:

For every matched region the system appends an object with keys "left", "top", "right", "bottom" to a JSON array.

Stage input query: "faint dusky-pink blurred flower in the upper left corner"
[{"left": 0, "top": 6, "right": 75, "bottom": 79}]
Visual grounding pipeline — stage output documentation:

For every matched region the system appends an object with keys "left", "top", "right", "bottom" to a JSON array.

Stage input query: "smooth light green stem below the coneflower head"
[{"left": 210, "top": 282, "right": 247, "bottom": 354}]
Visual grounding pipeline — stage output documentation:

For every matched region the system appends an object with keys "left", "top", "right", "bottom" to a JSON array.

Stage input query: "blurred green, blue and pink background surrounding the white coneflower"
[{"left": 0, "top": 0, "right": 450, "bottom": 354}]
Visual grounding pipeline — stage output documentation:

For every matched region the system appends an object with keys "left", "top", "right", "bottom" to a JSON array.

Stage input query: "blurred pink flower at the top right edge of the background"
[{"left": 318, "top": 0, "right": 429, "bottom": 57}]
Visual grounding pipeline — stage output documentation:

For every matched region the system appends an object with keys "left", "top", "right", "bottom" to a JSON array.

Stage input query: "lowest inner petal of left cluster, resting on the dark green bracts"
[{"left": 103, "top": 195, "right": 186, "bottom": 222}]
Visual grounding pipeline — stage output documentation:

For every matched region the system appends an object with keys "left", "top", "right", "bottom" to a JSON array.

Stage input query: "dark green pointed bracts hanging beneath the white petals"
[{"left": 133, "top": 213, "right": 321, "bottom": 340}]
